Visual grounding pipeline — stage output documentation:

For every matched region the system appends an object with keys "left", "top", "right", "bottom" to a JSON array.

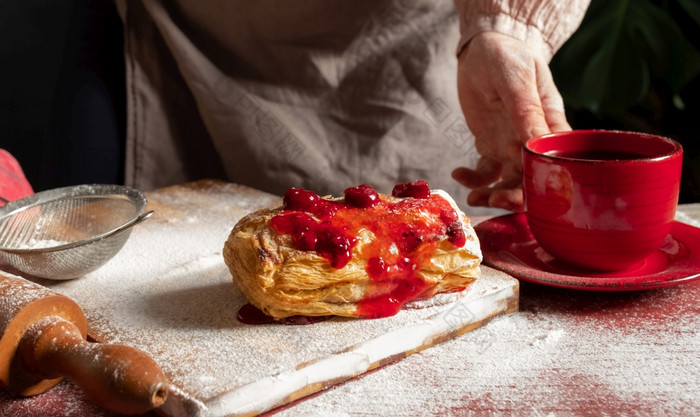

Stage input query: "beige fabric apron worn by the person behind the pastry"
[{"left": 120, "top": 0, "right": 498, "bottom": 214}]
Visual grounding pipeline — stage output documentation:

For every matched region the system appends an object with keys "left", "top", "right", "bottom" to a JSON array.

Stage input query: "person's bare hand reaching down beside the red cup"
[{"left": 452, "top": 32, "right": 571, "bottom": 211}]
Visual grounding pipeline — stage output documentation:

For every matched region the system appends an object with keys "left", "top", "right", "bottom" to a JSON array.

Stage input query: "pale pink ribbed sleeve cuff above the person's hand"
[{"left": 454, "top": 0, "right": 590, "bottom": 61}]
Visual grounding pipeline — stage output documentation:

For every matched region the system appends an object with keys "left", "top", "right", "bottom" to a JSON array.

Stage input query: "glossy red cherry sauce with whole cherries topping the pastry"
[{"left": 270, "top": 181, "right": 466, "bottom": 318}]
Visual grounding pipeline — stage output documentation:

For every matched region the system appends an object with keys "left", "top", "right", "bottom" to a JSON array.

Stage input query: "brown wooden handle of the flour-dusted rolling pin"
[{"left": 18, "top": 317, "right": 168, "bottom": 414}]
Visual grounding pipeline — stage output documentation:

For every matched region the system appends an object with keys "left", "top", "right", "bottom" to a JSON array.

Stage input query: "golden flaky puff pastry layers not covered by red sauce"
[{"left": 223, "top": 190, "right": 481, "bottom": 319}]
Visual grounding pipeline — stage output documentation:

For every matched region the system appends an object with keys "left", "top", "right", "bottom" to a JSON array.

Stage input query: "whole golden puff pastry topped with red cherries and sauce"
[{"left": 224, "top": 181, "right": 481, "bottom": 319}]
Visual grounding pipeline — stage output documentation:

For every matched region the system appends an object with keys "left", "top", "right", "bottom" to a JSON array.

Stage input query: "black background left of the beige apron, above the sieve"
[{"left": 0, "top": 0, "right": 125, "bottom": 191}]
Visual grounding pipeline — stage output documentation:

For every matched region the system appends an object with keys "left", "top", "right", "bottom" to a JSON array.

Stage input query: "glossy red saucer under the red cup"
[{"left": 474, "top": 213, "right": 700, "bottom": 291}]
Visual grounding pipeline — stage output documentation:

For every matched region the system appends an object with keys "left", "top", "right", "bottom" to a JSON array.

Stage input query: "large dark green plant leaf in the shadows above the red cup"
[{"left": 552, "top": 0, "right": 700, "bottom": 114}]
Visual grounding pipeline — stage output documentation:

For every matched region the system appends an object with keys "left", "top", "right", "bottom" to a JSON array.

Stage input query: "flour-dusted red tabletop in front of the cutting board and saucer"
[{"left": 275, "top": 276, "right": 700, "bottom": 417}]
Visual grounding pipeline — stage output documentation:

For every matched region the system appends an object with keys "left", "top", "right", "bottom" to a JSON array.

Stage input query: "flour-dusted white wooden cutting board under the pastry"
[{"left": 39, "top": 181, "right": 518, "bottom": 416}]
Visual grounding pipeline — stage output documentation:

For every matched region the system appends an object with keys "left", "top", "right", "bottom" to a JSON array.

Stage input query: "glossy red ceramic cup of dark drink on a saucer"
[{"left": 523, "top": 130, "right": 683, "bottom": 271}]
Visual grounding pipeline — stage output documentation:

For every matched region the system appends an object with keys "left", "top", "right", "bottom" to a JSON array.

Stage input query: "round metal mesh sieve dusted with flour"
[{"left": 0, "top": 184, "right": 153, "bottom": 279}]
